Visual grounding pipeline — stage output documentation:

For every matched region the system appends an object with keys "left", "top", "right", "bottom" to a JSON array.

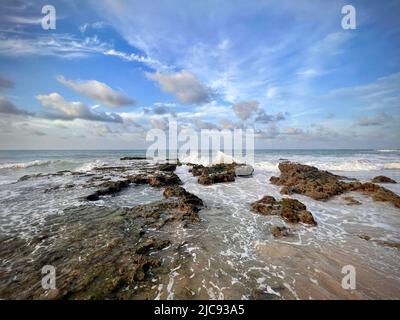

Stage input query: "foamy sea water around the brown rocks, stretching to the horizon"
[{"left": 0, "top": 150, "right": 400, "bottom": 299}]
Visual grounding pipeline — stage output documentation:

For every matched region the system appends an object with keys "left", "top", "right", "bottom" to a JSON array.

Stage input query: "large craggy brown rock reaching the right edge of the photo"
[{"left": 270, "top": 162, "right": 400, "bottom": 208}]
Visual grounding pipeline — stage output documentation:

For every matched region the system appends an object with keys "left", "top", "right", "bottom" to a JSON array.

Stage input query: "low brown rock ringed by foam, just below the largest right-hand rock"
[{"left": 251, "top": 196, "right": 317, "bottom": 226}]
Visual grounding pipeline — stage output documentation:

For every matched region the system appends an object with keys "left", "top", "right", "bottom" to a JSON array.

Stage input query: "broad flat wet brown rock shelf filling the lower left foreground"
[{"left": 0, "top": 191, "right": 201, "bottom": 299}]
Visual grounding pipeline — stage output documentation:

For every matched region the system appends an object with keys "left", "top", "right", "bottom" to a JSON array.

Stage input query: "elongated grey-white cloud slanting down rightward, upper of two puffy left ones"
[{"left": 57, "top": 76, "right": 135, "bottom": 107}]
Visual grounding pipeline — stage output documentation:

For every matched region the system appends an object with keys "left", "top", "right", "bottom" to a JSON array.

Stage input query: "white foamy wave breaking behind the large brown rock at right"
[{"left": 256, "top": 160, "right": 400, "bottom": 172}]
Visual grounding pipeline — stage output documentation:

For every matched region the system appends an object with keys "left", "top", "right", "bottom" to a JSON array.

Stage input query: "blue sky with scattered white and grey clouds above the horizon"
[{"left": 0, "top": 0, "right": 400, "bottom": 149}]
